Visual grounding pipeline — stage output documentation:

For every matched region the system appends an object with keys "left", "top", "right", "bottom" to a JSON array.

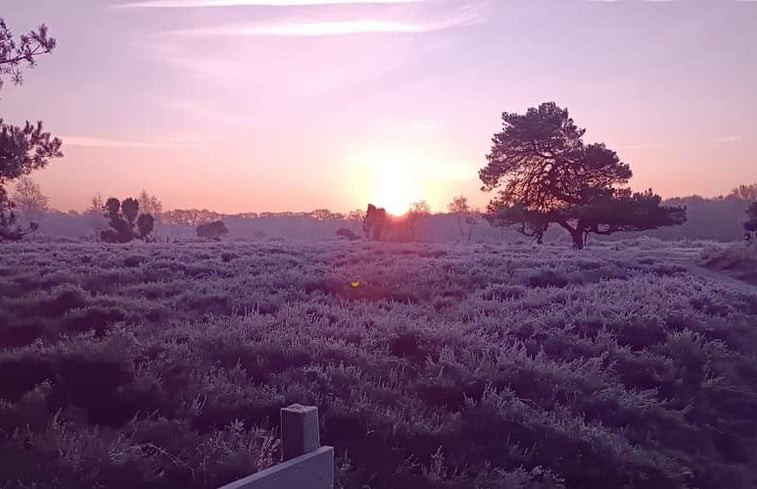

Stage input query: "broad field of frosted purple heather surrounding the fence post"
[{"left": 0, "top": 239, "right": 757, "bottom": 489}]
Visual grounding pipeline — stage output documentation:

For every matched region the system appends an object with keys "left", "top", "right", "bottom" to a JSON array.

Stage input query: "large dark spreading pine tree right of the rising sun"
[{"left": 479, "top": 102, "right": 686, "bottom": 249}]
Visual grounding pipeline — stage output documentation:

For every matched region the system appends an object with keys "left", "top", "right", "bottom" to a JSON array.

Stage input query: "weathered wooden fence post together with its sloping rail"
[{"left": 220, "top": 404, "right": 334, "bottom": 489}]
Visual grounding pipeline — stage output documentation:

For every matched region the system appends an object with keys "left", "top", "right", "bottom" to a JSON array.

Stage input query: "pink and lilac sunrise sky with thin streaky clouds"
[{"left": 0, "top": 0, "right": 757, "bottom": 213}]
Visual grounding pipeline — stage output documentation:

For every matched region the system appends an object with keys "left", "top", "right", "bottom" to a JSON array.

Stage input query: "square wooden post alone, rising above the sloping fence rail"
[{"left": 281, "top": 404, "right": 321, "bottom": 462}]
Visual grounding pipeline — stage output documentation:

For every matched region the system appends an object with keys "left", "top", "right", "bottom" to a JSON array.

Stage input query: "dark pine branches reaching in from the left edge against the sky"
[{"left": 0, "top": 18, "right": 63, "bottom": 240}]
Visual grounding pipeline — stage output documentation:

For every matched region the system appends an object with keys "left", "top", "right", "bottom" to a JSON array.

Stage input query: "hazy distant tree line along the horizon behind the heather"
[{"left": 9, "top": 187, "right": 754, "bottom": 243}]
